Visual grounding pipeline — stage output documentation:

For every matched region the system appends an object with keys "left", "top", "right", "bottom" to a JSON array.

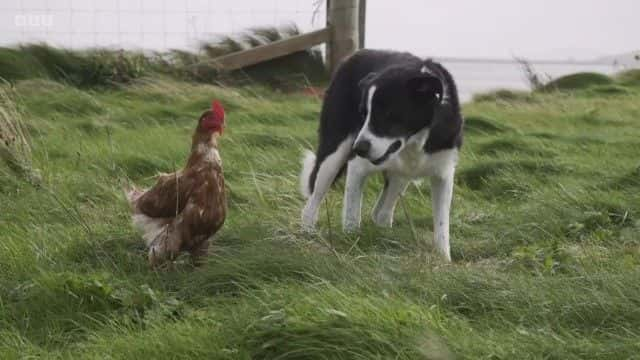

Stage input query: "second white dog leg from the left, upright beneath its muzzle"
[{"left": 342, "top": 158, "right": 369, "bottom": 232}]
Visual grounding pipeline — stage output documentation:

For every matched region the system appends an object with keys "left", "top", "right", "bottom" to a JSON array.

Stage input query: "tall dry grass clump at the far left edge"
[{"left": 0, "top": 86, "right": 40, "bottom": 182}]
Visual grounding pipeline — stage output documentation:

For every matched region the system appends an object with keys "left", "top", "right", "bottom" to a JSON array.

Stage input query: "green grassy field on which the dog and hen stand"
[{"left": 0, "top": 69, "right": 640, "bottom": 359}]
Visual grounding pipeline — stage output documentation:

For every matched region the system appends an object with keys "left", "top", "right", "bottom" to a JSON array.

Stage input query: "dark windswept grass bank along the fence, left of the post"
[{"left": 0, "top": 25, "right": 327, "bottom": 89}]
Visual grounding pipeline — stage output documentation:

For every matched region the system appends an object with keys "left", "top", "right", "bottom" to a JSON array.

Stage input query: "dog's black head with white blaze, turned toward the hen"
[{"left": 353, "top": 65, "right": 444, "bottom": 165}]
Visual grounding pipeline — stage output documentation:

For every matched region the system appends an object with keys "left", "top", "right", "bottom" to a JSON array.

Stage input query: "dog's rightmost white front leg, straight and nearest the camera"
[{"left": 431, "top": 170, "right": 454, "bottom": 261}]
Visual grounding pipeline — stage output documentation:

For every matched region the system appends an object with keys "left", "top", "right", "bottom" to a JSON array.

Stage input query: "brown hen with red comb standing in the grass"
[{"left": 126, "top": 101, "right": 226, "bottom": 267}]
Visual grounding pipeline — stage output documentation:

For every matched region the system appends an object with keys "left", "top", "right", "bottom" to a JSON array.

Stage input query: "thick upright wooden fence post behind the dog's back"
[{"left": 327, "top": 0, "right": 360, "bottom": 74}]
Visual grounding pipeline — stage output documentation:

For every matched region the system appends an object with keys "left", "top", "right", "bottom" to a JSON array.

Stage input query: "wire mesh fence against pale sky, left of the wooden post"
[{"left": 0, "top": 0, "right": 326, "bottom": 50}]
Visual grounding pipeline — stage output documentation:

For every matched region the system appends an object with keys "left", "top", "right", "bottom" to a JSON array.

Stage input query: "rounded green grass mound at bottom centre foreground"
[{"left": 242, "top": 286, "right": 454, "bottom": 360}]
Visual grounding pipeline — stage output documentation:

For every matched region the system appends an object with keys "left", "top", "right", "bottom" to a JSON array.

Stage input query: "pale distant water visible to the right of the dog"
[{"left": 442, "top": 60, "right": 622, "bottom": 102}]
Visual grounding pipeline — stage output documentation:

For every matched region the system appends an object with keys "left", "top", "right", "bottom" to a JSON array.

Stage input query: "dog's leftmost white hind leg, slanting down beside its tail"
[{"left": 302, "top": 136, "right": 353, "bottom": 230}]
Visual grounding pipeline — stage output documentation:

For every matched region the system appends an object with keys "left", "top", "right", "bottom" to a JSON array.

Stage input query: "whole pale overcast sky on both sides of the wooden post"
[{"left": 0, "top": 0, "right": 640, "bottom": 59}]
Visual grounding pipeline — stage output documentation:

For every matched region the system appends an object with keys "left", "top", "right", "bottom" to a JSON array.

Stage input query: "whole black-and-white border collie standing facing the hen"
[{"left": 300, "top": 50, "right": 463, "bottom": 261}]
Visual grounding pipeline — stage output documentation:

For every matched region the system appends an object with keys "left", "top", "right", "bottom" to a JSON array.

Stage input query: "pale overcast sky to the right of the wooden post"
[{"left": 367, "top": 0, "right": 640, "bottom": 59}]
